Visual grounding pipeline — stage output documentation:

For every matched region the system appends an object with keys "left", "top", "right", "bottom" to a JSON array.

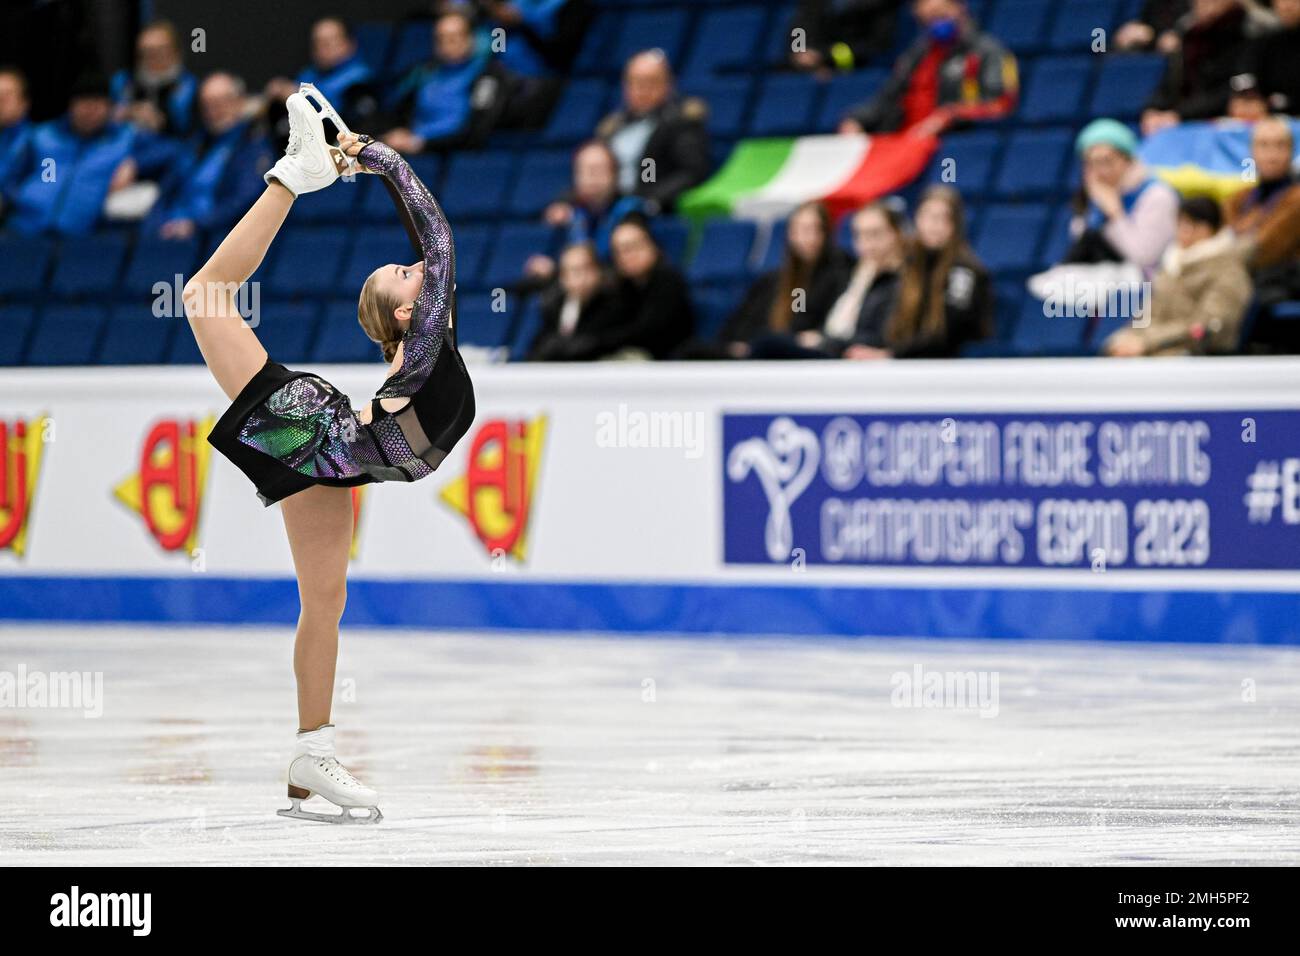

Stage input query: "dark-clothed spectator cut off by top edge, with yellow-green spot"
[{"left": 787, "top": 0, "right": 902, "bottom": 78}]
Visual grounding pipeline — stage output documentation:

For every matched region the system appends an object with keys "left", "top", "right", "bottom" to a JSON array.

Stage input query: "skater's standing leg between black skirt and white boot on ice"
[{"left": 281, "top": 485, "right": 352, "bottom": 730}]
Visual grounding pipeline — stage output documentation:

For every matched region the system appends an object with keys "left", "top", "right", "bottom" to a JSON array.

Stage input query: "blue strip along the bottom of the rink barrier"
[{"left": 0, "top": 578, "right": 1300, "bottom": 644}]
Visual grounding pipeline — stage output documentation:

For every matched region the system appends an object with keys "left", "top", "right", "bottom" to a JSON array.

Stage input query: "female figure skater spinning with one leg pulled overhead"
[{"left": 183, "top": 91, "right": 475, "bottom": 822}]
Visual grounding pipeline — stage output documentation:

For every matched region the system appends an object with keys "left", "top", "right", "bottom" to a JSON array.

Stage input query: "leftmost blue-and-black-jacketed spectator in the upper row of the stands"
[{"left": 112, "top": 20, "right": 199, "bottom": 137}]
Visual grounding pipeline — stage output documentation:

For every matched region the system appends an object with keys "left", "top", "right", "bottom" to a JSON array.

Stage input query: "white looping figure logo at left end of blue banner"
[{"left": 727, "top": 415, "right": 822, "bottom": 561}]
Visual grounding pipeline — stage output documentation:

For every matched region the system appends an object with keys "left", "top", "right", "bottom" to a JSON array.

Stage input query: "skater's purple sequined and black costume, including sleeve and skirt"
[{"left": 208, "top": 143, "right": 475, "bottom": 505}]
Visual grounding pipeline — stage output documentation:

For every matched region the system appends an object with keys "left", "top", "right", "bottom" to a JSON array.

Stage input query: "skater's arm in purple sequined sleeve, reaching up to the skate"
[{"left": 358, "top": 143, "right": 456, "bottom": 398}]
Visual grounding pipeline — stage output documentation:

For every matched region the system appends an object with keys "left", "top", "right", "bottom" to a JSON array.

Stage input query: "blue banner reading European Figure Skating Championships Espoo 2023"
[{"left": 723, "top": 410, "right": 1300, "bottom": 571}]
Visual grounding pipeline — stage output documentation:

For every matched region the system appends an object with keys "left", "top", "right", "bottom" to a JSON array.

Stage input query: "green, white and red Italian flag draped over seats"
[{"left": 677, "top": 133, "right": 939, "bottom": 220}]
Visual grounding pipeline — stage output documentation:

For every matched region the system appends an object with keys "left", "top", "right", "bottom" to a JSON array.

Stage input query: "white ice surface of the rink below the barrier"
[{"left": 0, "top": 626, "right": 1300, "bottom": 865}]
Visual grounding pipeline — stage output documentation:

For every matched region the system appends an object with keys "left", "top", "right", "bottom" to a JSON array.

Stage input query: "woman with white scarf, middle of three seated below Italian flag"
[{"left": 753, "top": 202, "right": 907, "bottom": 359}]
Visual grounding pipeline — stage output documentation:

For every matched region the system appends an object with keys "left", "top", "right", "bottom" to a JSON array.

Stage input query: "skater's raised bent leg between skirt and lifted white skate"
[{"left": 185, "top": 183, "right": 294, "bottom": 399}]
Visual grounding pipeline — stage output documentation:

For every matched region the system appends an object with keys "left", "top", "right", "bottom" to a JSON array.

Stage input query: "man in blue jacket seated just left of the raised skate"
[{"left": 146, "top": 73, "right": 274, "bottom": 239}]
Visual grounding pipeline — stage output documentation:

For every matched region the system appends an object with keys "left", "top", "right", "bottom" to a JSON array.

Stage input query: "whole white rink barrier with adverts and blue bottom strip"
[{"left": 0, "top": 358, "right": 1300, "bottom": 644}]
